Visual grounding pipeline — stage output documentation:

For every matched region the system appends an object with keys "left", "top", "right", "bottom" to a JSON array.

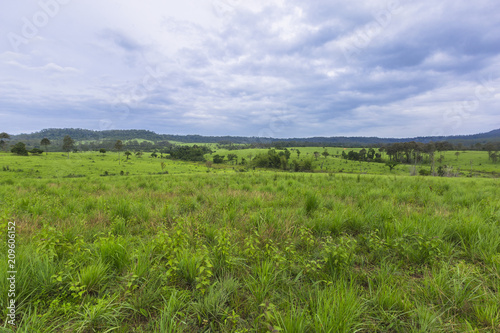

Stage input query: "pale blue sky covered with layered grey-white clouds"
[{"left": 0, "top": 0, "right": 500, "bottom": 138}]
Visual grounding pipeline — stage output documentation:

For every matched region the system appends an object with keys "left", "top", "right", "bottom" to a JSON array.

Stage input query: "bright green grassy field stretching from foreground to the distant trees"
[{"left": 0, "top": 147, "right": 500, "bottom": 332}]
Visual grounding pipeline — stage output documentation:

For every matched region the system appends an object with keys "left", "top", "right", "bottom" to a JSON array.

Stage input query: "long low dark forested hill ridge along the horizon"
[{"left": 12, "top": 128, "right": 500, "bottom": 146}]
